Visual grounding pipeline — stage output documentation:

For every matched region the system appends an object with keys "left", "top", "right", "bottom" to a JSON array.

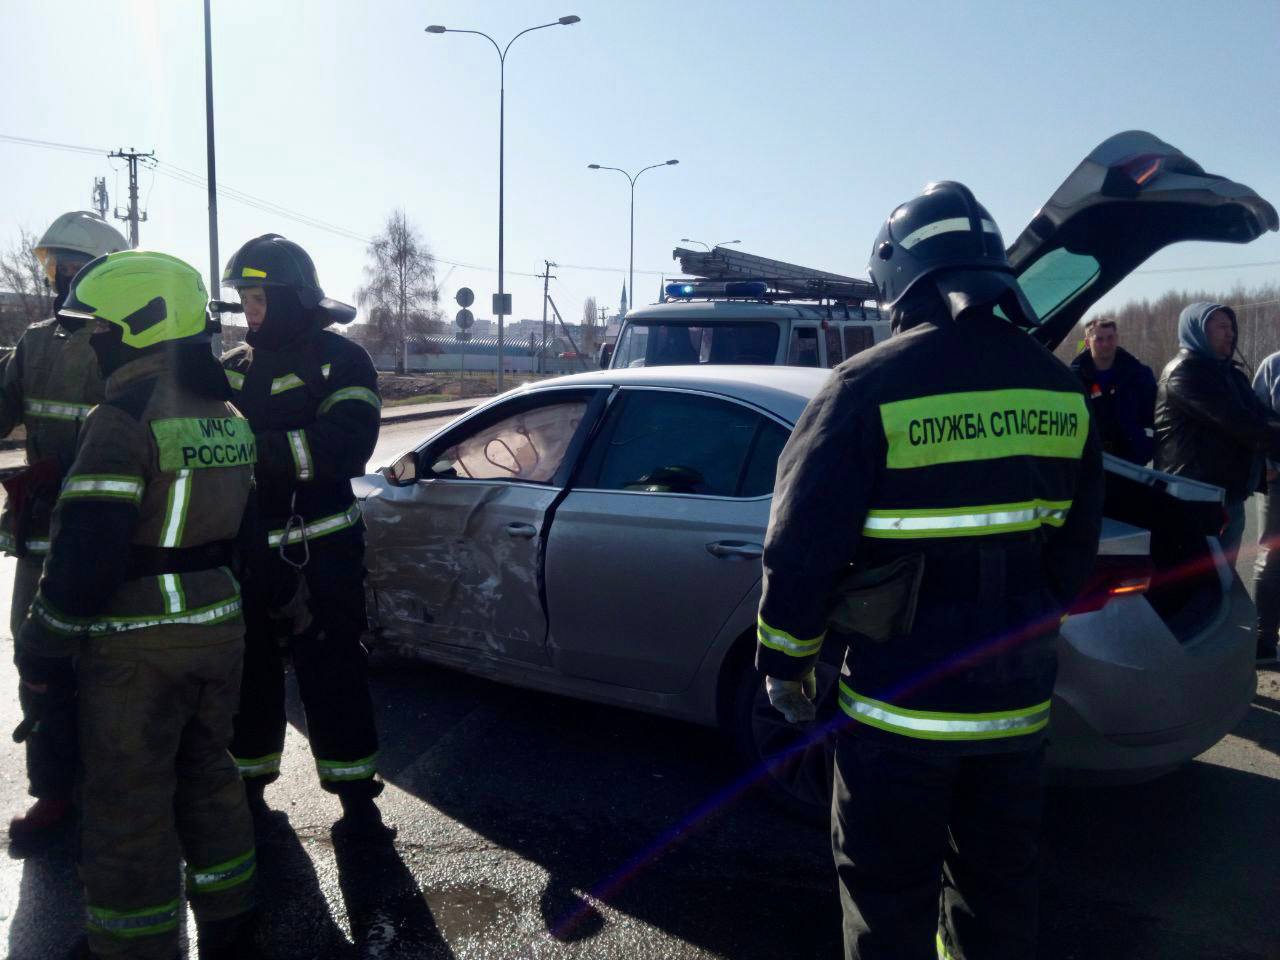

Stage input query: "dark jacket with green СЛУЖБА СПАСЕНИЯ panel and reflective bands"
[{"left": 756, "top": 304, "right": 1102, "bottom": 751}]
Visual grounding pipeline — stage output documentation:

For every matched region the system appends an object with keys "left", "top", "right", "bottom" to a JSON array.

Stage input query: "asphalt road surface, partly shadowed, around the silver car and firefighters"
[{"left": 0, "top": 422, "right": 1280, "bottom": 960}]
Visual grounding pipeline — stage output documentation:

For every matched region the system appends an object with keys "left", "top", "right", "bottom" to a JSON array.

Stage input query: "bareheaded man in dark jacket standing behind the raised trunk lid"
[{"left": 1071, "top": 316, "right": 1156, "bottom": 463}]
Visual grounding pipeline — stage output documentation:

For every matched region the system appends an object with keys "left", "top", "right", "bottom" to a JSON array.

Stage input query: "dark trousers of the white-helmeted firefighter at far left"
[{"left": 9, "top": 557, "right": 77, "bottom": 800}]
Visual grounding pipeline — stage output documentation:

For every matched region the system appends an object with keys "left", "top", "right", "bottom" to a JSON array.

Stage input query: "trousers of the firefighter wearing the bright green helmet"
[{"left": 78, "top": 627, "right": 256, "bottom": 960}]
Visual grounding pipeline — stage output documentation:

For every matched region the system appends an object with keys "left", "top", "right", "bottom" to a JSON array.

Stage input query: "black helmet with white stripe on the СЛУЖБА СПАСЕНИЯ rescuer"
[{"left": 868, "top": 180, "right": 1036, "bottom": 325}]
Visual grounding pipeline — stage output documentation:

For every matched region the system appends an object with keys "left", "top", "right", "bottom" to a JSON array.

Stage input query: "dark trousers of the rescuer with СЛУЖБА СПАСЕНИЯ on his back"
[{"left": 832, "top": 731, "right": 1043, "bottom": 960}]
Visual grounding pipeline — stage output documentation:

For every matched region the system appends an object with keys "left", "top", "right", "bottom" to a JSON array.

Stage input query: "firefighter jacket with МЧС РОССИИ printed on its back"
[{"left": 23, "top": 353, "right": 256, "bottom": 650}]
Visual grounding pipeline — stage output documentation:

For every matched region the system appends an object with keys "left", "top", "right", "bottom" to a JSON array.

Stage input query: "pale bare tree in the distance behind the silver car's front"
[{"left": 356, "top": 210, "right": 442, "bottom": 374}]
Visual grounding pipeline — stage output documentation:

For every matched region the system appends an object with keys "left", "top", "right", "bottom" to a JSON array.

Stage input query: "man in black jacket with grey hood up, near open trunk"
[{"left": 1155, "top": 302, "right": 1280, "bottom": 564}]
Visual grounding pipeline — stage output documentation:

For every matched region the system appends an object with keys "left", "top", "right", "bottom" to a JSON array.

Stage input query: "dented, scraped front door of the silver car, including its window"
[{"left": 364, "top": 388, "right": 605, "bottom": 663}]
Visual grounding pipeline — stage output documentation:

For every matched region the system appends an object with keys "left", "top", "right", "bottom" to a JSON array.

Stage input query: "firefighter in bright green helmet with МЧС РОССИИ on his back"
[{"left": 18, "top": 251, "right": 256, "bottom": 960}]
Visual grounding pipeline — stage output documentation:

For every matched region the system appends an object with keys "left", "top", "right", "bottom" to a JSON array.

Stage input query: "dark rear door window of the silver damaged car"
[{"left": 580, "top": 390, "right": 776, "bottom": 497}]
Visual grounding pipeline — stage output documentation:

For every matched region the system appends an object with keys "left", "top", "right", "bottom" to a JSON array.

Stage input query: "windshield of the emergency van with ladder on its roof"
[{"left": 613, "top": 320, "right": 780, "bottom": 367}]
